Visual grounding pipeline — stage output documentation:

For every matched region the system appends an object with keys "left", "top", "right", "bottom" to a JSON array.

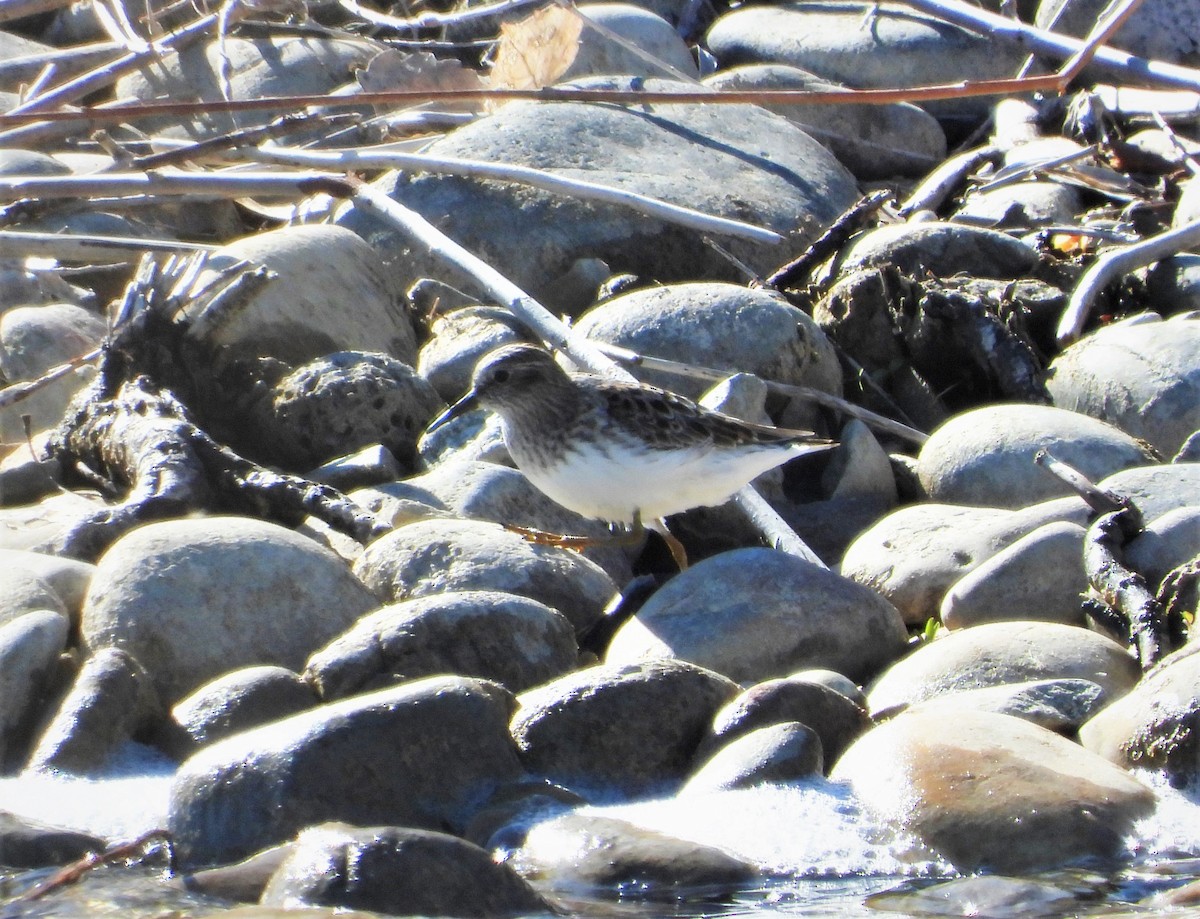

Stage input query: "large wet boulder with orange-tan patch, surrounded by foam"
[{"left": 832, "top": 711, "right": 1154, "bottom": 873}]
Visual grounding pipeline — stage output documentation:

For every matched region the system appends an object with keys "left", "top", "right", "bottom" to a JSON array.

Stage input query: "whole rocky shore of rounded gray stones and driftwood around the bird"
[{"left": 0, "top": 0, "right": 1200, "bottom": 917}]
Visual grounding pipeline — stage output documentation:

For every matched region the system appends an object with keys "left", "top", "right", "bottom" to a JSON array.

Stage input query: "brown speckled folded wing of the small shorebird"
[{"left": 596, "top": 380, "right": 820, "bottom": 450}]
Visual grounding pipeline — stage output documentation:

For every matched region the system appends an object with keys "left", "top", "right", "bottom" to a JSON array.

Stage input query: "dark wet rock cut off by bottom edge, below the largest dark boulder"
[{"left": 260, "top": 823, "right": 556, "bottom": 919}]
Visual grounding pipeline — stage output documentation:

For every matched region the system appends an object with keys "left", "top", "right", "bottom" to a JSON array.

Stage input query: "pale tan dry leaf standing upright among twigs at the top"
[{"left": 490, "top": 6, "right": 583, "bottom": 89}]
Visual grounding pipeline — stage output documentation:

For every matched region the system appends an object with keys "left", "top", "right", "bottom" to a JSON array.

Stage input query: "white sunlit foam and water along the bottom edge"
[{"left": 0, "top": 750, "right": 1200, "bottom": 919}]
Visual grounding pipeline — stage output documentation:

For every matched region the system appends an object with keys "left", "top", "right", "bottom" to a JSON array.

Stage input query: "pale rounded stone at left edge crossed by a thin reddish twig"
[{"left": 0, "top": 304, "right": 106, "bottom": 443}]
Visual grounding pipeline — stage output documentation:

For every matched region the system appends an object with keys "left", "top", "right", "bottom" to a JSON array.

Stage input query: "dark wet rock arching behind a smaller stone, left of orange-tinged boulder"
[{"left": 698, "top": 677, "right": 871, "bottom": 765}]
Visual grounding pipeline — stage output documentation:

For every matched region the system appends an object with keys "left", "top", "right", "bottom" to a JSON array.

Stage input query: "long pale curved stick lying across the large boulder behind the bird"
[{"left": 247, "top": 146, "right": 784, "bottom": 245}]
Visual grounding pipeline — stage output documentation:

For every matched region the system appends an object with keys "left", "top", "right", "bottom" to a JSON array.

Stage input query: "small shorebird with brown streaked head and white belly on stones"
[{"left": 428, "top": 344, "right": 833, "bottom": 561}]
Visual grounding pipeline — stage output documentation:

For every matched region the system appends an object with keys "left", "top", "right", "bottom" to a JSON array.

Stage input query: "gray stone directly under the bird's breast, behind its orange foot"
[{"left": 398, "top": 460, "right": 634, "bottom": 584}]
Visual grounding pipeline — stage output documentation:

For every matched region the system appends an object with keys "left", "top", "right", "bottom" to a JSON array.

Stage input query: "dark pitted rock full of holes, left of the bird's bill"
[{"left": 254, "top": 352, "right": 444, "bottom": 470}]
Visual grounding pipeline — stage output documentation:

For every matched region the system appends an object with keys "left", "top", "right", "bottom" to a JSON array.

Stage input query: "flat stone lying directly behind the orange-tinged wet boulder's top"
[{"left": 908, "top": 678, "right": 1105, "bottom": 734}]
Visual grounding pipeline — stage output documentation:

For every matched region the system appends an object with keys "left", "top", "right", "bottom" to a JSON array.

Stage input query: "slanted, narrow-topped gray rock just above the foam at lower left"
[{"left": 29, "top": 648, "right": 164, "bottom": 775}]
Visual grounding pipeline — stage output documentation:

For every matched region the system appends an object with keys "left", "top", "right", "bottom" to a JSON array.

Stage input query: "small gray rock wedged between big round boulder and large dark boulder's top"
[{"left": 170, "top": 666, "right": 318, "bottom": 746}]
